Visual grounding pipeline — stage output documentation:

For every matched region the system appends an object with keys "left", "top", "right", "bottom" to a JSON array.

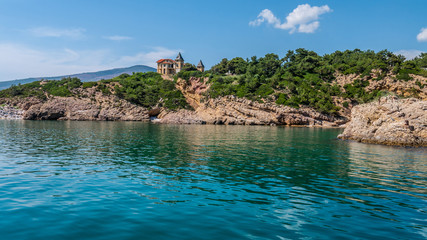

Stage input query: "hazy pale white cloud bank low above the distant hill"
[{"left": 0, "top": 43, "right": 179, "bottom": 81}]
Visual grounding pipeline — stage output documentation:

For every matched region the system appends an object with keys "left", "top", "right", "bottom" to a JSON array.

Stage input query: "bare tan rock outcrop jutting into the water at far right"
[{"left": 338, "top": 96, "right": 427, "bottom": 147}]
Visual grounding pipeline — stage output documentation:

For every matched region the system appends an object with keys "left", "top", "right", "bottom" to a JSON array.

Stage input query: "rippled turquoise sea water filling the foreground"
[{"left": 0, "top": 120, "right": 427, "bottom": 239}]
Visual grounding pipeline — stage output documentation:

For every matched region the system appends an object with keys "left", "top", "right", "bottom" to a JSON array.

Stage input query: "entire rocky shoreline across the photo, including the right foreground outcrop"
[{"left": 0, "top": 75, "right": 427, "bottom": 147}]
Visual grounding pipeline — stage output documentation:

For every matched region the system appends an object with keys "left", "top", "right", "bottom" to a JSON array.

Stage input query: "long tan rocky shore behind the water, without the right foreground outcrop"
[{"left": 0, "top": 78, "right": 348, "bottom": 127}]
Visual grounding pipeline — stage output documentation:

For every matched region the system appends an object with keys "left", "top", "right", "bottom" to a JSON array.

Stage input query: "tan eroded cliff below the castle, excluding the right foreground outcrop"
[{"left": 159, "top": 78, "right": 347, "bottom": 127}]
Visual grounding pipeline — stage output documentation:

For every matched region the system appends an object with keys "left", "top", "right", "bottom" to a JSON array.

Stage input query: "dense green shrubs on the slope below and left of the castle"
[{"left": 0, "top": 72, "right": 189, "bottom": 110}]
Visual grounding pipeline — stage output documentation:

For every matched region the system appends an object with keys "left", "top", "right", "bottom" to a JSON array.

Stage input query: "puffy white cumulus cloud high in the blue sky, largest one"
[{"left": 249, "top": 4, "right": 332, "bottom": 33}]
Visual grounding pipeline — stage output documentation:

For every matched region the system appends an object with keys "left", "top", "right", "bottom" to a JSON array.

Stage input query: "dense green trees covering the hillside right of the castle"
[{"left": 177, "top": 49, "right": 427, "bottom": 114}]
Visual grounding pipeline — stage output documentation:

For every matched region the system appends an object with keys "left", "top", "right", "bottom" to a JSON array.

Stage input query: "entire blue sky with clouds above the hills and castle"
[{"left": 0, "top": 0, "right": 427, "bottom": 81}]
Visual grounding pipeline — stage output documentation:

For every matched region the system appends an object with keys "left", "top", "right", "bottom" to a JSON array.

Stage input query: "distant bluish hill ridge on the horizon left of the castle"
[{"left": 0, "top": 65, "right": 156, "bottom": 90}]
